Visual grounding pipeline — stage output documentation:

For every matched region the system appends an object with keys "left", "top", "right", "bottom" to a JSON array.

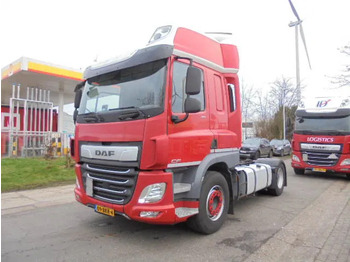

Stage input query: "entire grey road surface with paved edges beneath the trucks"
[{"left": 1, "top": 157, "right": 350, "bottom": 261}]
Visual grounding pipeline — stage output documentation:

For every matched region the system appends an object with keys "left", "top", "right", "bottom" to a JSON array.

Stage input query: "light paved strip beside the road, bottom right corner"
[{"left": 244, "top": 181, "right": 350, "bottom": 262}]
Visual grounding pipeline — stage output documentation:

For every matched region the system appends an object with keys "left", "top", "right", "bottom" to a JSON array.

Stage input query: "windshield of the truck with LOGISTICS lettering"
[{"left": 295, "top": 116, "right": 350, "bottom": 135}]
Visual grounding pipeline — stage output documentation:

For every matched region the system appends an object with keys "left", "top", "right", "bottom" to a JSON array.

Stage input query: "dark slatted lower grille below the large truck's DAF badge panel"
[{"left": 81, "top": 163, "right": 138, "bottom": 205}]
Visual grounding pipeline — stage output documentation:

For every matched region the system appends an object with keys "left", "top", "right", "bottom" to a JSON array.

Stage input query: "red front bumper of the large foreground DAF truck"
[{"left": 74, "top": 164, "right": 199, "bottom": 224}]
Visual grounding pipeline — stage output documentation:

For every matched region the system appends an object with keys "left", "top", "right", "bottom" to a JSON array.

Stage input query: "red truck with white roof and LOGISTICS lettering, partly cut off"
[{"left": 292, "top": 96, "right": 350, "bottom": 178}]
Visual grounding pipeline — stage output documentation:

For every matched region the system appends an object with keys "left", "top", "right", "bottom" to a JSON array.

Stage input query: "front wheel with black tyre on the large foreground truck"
[{"left": 187, "top": 171, "right": 230, "bottom": 234}]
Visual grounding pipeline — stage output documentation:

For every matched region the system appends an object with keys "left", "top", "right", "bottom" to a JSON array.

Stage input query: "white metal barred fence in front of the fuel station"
[{"left": 1, "top": 85, "right": 71, "bottom": 157}]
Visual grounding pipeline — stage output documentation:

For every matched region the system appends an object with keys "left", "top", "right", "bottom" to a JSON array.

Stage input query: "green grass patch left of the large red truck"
[{"left": 1, "top": 157, "right": 75, "bottom": 192}]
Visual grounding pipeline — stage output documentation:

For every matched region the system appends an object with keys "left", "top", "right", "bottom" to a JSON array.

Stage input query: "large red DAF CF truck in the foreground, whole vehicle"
[{"left": 71, "top": 26, "right": 287, "bottom": 234}]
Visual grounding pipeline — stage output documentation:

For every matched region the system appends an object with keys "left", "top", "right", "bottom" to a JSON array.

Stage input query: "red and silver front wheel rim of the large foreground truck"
[{"left": 206, "top": 185, "right": 225, "bottom": 221}]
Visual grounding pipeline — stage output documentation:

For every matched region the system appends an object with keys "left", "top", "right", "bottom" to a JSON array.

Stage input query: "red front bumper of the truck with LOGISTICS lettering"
[{"left": 291, "top": 151, "right": 350, "bottom": 174}]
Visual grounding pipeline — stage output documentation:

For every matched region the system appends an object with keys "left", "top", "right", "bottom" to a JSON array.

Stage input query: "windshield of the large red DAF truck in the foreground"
[{"left": 78, "top": 59, "right": 167, "bottom": 122}]
